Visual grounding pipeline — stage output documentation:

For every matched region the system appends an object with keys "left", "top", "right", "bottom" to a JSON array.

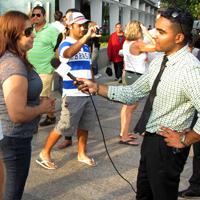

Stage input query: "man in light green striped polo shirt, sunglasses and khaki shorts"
[{"left": 28, "top": 6, "right": 60, "bottom": 126}]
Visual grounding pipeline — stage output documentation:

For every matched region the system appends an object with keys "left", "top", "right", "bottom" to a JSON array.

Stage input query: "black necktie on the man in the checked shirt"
[{"left": 134, "top": 55, "right": 168, "bottom": 134}]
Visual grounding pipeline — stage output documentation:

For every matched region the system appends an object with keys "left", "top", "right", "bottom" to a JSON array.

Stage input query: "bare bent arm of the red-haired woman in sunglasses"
[{"left": 3, "top": 75, "right": 56, "bottom": 123}]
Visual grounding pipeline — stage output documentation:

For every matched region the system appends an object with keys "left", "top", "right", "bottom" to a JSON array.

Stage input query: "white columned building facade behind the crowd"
[{"left": 59, "top": 0, "right": 158, "bottom": 34}]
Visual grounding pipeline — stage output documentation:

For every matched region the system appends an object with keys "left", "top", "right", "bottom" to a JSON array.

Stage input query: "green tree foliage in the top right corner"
[{"left": 160, "top": 0, "right": 200, "bottom": 19}]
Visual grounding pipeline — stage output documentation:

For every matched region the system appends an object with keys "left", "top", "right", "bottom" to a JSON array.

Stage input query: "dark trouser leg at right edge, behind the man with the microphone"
[{"left": 189, "top": 142, "right": 200, "bottom": 195}]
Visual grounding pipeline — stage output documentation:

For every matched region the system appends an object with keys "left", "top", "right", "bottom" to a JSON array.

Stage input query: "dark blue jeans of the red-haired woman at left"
[{"left": 0, "top": 136, "right": 32, "bottom": 200}]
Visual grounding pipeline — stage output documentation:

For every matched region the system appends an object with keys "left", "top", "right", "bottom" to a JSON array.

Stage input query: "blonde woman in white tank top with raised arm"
[{"left": 119, "top": 21, "right": 155, "bottom": 146}]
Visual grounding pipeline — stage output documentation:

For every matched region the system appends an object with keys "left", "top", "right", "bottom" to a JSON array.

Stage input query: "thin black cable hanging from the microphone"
[{"left": 88, "top": 90, "right": 137, "bottom": 194}]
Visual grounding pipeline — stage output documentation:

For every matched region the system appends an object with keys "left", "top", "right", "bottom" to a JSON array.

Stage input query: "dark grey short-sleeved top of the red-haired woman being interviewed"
[{"left": 0, "top": 51, "right": 42, "bottom": 138}]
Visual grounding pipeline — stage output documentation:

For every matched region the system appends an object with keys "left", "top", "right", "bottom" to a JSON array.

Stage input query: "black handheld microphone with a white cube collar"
[{"left": 51, "top": 58, "right": 82, "bottom": 85}]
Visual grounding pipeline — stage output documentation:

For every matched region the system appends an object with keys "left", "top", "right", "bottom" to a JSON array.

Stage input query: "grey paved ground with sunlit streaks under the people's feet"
[{"left": 23, "top": 66, "right": 196, "bottom": 200}]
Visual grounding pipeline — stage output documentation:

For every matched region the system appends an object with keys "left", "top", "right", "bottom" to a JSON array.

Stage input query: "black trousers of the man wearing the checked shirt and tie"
[{"left": 136, "top": 135, "right": 190, "bottom": 200}]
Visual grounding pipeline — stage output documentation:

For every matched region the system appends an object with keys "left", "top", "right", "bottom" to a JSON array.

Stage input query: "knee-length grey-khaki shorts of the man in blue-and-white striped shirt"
[{"left": 54, "top": 96, "right": 97, "bottom": 137}]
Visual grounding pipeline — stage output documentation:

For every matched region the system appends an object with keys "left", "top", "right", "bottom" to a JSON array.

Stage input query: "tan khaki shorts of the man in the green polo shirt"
[{"left": 39, "top": 73, "right": 56, "bottom": 97}]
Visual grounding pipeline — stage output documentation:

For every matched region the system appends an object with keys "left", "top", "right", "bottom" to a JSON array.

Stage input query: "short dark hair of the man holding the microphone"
[{"left": 161, "top": 7, "right": 194, "bottom": 43}]
